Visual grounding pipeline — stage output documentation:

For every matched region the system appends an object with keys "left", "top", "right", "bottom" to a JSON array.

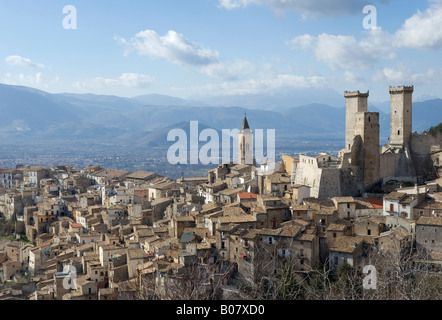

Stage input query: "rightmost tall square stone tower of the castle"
[{"left": 389, "top": 86, "right": 414, "bottom": 147}]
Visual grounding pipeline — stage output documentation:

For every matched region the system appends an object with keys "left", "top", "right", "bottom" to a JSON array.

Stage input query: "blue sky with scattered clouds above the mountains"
[{"left": 0, "top": 0, "right": 442, "bottom": 101}]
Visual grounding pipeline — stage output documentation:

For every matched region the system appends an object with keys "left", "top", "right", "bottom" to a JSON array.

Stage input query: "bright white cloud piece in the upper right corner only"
[{"left": 395, "top": 1, "right": 442, "bottom": 49}]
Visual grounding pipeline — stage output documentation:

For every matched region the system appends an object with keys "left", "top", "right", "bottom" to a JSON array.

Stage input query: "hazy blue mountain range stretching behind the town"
[{"left": 0, "top": 84, "right": 442, "bottom": 148}]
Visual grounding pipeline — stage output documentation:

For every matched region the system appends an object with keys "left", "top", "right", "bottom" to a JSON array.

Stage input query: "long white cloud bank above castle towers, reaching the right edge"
[{"left": 287, "top": 0, "right": 442, "bottom": 69}]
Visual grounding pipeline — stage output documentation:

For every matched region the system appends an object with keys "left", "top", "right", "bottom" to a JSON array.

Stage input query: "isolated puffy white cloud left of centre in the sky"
[{"left": 115, "top": 30, "right": 219, "bottom": 65}]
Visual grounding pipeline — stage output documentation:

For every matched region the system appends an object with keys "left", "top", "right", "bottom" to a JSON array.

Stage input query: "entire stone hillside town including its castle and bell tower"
[{"left": 0, "top": 87, "right": 442, "bottom": 300}]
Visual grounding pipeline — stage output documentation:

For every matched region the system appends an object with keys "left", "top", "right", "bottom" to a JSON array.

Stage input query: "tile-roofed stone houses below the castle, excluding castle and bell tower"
[{"left": 0, "top": 156, "right": 442, "bottom": 300}]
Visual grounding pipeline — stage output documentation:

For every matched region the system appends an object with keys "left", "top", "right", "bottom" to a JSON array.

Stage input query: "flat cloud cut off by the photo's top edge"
[{"left": 218, "top": 0, "right": 387, "bottom": 18}]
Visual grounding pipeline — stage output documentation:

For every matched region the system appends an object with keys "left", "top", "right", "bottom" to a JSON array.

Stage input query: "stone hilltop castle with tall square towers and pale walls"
[{"left": 291, "top": 86, "right": 434, "bottom": 198}]
